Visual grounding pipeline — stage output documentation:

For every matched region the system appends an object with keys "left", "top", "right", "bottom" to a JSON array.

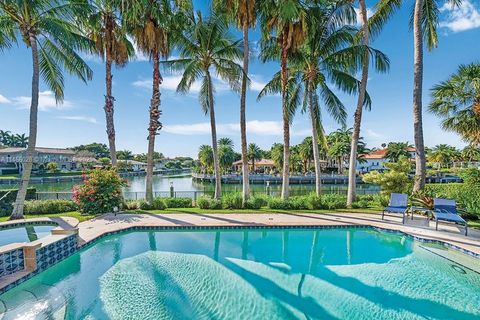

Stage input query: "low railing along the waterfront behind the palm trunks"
[{"left": 36, "top": 188, "right": 379, "bottom": 200}]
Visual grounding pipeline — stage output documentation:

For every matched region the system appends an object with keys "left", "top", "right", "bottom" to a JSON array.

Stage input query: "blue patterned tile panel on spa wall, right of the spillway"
[{"left": 37, "top": 235, "right": 77, "bottom": 272}]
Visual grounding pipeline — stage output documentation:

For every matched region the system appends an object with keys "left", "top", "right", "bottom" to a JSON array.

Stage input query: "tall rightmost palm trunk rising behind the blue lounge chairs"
[{"left": 413, "top": 0, "right": 426, "bottom": 192}]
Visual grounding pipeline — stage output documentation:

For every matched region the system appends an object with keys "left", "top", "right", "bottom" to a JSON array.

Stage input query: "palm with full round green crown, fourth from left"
[{"left": 166, "top": 14, "right": 244, "bottom": 199}]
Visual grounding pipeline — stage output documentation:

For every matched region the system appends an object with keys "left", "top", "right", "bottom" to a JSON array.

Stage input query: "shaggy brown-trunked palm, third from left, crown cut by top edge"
[{"left": 122, "top": 0, "right": 191, "bottom": 203}]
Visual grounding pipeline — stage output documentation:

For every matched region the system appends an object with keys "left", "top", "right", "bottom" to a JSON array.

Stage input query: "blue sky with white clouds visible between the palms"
[{"left": 0, "top": 0, "right": 480, "bottom": 157}]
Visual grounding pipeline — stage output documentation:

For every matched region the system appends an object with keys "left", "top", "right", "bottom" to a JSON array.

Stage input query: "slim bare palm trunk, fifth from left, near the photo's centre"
[{"left": 240, "top": 19, "right": 250, "bottom": 205}]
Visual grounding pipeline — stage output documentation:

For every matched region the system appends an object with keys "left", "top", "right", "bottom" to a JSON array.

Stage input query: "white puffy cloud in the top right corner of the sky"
[{"left": 440, "top": 0, "right": 480, "bottom": 32}]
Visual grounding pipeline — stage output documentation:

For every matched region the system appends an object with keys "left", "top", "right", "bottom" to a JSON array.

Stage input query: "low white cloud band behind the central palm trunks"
[{"left": 163, "top": 120, "right": 311, "bottom": 136}]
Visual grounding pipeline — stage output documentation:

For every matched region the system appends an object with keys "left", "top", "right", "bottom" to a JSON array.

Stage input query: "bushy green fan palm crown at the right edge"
[{"left": 429, "top": 63, "right": 480, "bottom": 146}]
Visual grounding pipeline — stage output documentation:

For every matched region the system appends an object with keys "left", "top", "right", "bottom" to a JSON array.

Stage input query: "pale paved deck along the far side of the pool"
[{"left": 78, "top": 212, "right": 480, "bottom": 255}]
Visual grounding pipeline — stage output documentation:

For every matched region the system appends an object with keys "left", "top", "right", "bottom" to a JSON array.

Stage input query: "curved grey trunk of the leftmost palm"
[{"left": 10, "top": 34, "right": 40, "bottom": 220}]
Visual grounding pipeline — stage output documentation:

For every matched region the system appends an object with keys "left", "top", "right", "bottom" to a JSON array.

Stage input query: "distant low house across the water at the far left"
[{"left": 0, "top": 147, "right": 98, "bottom": 172}]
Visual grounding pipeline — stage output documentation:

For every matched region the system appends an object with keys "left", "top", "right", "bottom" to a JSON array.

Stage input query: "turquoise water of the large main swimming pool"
[{"left": 0, "top": 228, "right": 480, "bottom": 320}]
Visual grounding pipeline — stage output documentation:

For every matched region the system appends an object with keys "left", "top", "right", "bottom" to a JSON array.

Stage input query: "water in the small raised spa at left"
[{"left": 0, "top": 224, "right": 57, "bottom": 247}]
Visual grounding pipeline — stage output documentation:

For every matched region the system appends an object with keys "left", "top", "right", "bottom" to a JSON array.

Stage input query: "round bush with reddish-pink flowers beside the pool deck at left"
[{"left": 73, "top": 169, "right": 127, "bottom": 214}]
